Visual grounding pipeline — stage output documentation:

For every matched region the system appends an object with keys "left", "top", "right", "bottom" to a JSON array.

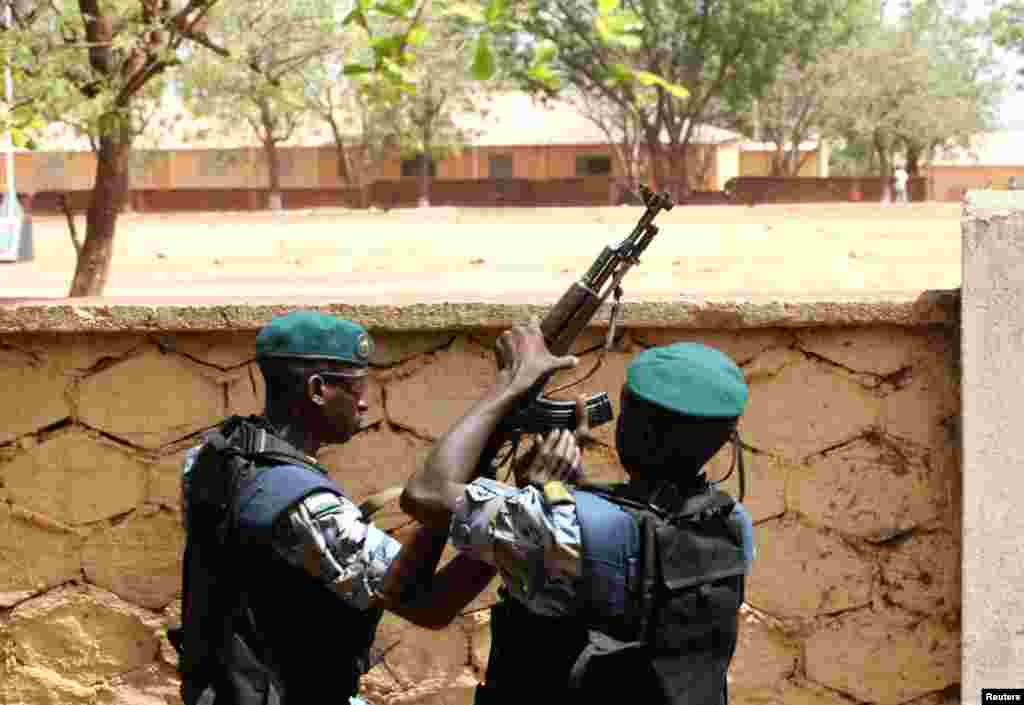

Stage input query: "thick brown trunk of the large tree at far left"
[{"left": 68, "top": 118, "right": 132, "bottom": 297}]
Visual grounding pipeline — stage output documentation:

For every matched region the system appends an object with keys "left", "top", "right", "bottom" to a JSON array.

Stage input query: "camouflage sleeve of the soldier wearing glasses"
[{"left": 273, "top": 492, "right": 401, "bottom": 610}]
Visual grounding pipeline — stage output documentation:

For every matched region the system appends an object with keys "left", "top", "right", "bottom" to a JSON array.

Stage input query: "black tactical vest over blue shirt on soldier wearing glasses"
[{"left": 172, "top": 419, "right": 382, "bottom": 705}]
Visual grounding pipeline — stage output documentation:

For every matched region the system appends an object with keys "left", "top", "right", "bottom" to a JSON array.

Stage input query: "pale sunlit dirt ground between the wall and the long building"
[{"left": 0, "top": 203, "right": 961, "bottom": 303}]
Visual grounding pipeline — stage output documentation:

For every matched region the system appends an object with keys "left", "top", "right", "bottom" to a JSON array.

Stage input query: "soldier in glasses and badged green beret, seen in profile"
[{"left": 175, "top": 310, "right": 495, "bottom": 705}]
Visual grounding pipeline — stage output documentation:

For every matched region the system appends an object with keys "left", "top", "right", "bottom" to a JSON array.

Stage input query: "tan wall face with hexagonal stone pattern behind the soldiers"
[{"left": 0, "top": 326, "right": 961, "bottom": 705}]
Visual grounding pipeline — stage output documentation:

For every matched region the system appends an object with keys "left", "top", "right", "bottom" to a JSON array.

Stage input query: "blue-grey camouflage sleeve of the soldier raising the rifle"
[{"left": 451, "top": 478, "right": 582, "bottom": 616}]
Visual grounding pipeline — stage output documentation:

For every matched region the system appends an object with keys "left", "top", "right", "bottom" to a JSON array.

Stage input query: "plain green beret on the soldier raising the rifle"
[{"left": 626, "top": 342, "right": 748, "bottom": 418}]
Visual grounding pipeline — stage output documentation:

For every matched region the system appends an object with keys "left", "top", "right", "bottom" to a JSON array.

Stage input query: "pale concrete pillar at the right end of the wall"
[{"left": 961, "top": 191, "right": 1024, "bottom": 705}]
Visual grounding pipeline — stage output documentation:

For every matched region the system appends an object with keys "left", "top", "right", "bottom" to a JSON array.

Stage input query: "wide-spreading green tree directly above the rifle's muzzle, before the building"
[{"left": 495, "top": 0, "right": 862, "bottom": 198}]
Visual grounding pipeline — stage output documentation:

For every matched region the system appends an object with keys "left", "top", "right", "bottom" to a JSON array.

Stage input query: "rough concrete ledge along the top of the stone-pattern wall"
[{"left": 0, "top": 289, "right": 959, "bottom": 334}]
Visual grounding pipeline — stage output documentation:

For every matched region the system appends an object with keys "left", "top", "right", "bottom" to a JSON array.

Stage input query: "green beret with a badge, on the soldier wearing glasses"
[{"left": 256, "top": 310, "right": 374, "bottom": 367}]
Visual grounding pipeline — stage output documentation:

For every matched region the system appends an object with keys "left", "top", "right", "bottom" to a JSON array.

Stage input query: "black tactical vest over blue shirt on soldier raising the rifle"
[{"left": 476, "top": 487, "right": 746, "bottom": 705}]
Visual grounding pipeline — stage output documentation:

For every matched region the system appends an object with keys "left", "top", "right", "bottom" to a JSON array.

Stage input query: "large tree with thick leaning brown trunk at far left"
[{"left": 0, "top": 0, "right": 239, "bottom": 296}]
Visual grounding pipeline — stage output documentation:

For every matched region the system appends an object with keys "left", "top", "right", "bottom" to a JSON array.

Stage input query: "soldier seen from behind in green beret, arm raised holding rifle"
[{"left": 402, "top": 320, "right": 754, "bottom": 705}]
